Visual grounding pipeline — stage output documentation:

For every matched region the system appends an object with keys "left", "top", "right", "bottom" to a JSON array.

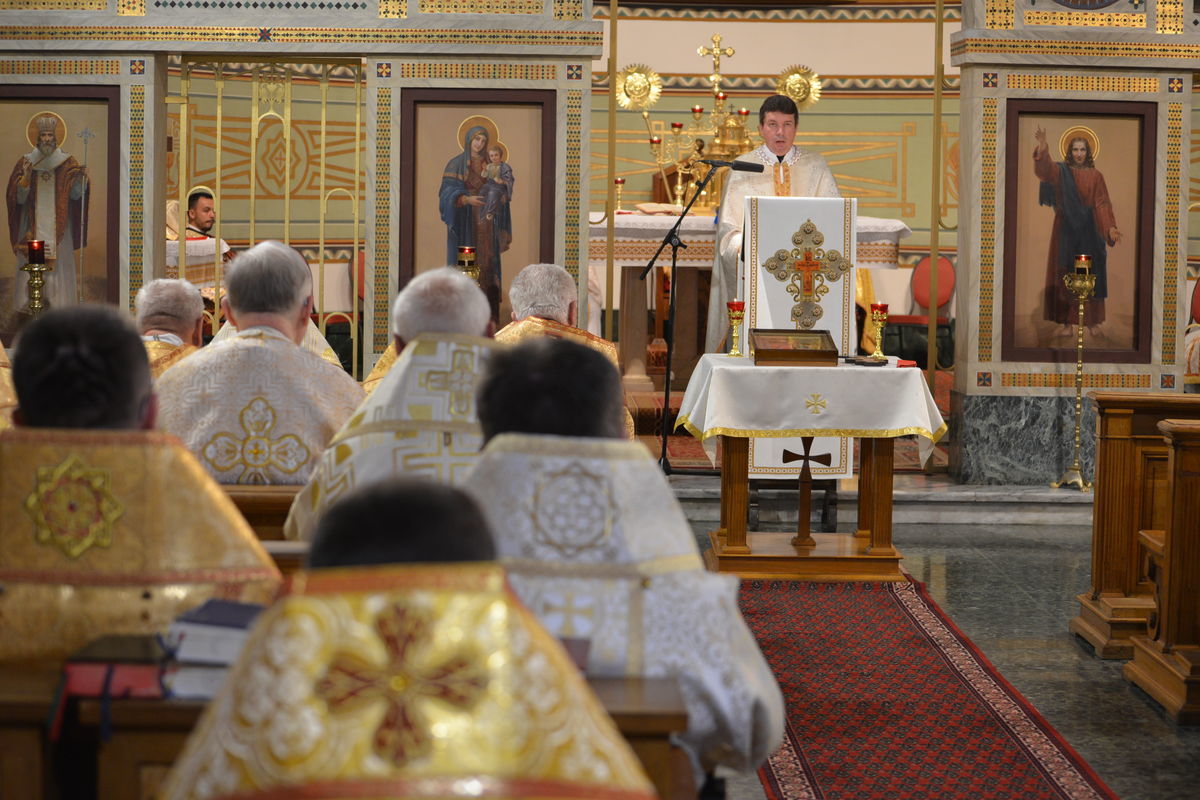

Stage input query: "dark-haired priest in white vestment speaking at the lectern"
[{"left": 704, "top": 95, "right": 841, "bottom": 353}]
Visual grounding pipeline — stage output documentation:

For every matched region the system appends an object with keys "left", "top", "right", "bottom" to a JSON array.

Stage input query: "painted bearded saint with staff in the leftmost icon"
[{"left": 6, "top": 113, "right": 88, "bottom": 308}]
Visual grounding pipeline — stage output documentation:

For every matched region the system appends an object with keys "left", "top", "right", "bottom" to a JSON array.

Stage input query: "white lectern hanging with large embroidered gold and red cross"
[{"left": 738, "top": 197, "right": 858, "bottom": 479}]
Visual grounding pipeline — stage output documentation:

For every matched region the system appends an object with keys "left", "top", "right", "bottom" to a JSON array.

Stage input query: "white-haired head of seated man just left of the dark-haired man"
[{"left": 391, "top": 266, "right": 492, "bottom": 347}]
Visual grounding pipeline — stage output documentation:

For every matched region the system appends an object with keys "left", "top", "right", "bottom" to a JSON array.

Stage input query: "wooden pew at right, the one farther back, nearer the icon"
[{"left": 1068, "top": 392, "right": 1200, "bottom": 658}]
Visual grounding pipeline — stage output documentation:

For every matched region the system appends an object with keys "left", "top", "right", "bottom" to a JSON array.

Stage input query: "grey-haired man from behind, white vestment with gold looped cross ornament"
[{"left": 158, "top": 241, "right": 362, "bottom": 483}]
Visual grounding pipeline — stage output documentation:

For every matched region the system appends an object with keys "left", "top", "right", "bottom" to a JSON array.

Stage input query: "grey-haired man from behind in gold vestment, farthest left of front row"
[{"left": 133, "top": 278, "right": 204, "bottom": 378}]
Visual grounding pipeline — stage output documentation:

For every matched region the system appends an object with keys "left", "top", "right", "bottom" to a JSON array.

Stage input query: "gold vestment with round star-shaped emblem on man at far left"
[{"left": 0, "top": 428, "right": 282, "bottom": 661}]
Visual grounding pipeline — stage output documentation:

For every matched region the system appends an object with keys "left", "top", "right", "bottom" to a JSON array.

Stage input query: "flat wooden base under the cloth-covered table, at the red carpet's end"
[{"left": 704, "top": 530, "right": 907, "bottom": 581}]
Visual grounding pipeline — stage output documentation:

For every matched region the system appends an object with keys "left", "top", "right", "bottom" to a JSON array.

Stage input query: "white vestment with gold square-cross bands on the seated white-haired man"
[{"left": 283, "top": 333, "right": 496, "bottom": 540}]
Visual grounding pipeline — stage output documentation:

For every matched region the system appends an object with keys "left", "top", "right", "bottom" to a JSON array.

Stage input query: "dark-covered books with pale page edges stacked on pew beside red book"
[{"left": 162, "top": 600, "right": 263, "bottom": 700}]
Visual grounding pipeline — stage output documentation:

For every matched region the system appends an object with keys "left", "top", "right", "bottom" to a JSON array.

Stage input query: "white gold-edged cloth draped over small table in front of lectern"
[{"left": 676, "top": 353, "right": 946, "bottom": 463}]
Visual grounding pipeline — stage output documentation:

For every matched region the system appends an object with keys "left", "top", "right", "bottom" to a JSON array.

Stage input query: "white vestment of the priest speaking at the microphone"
[{"left": 704, "top": 145, "right": 841, "bottom": 353}]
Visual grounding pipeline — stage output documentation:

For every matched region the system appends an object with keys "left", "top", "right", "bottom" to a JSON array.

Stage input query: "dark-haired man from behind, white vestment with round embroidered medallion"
[{"left": 466, "top": 339, "right": 784, "bottom": 781}]
